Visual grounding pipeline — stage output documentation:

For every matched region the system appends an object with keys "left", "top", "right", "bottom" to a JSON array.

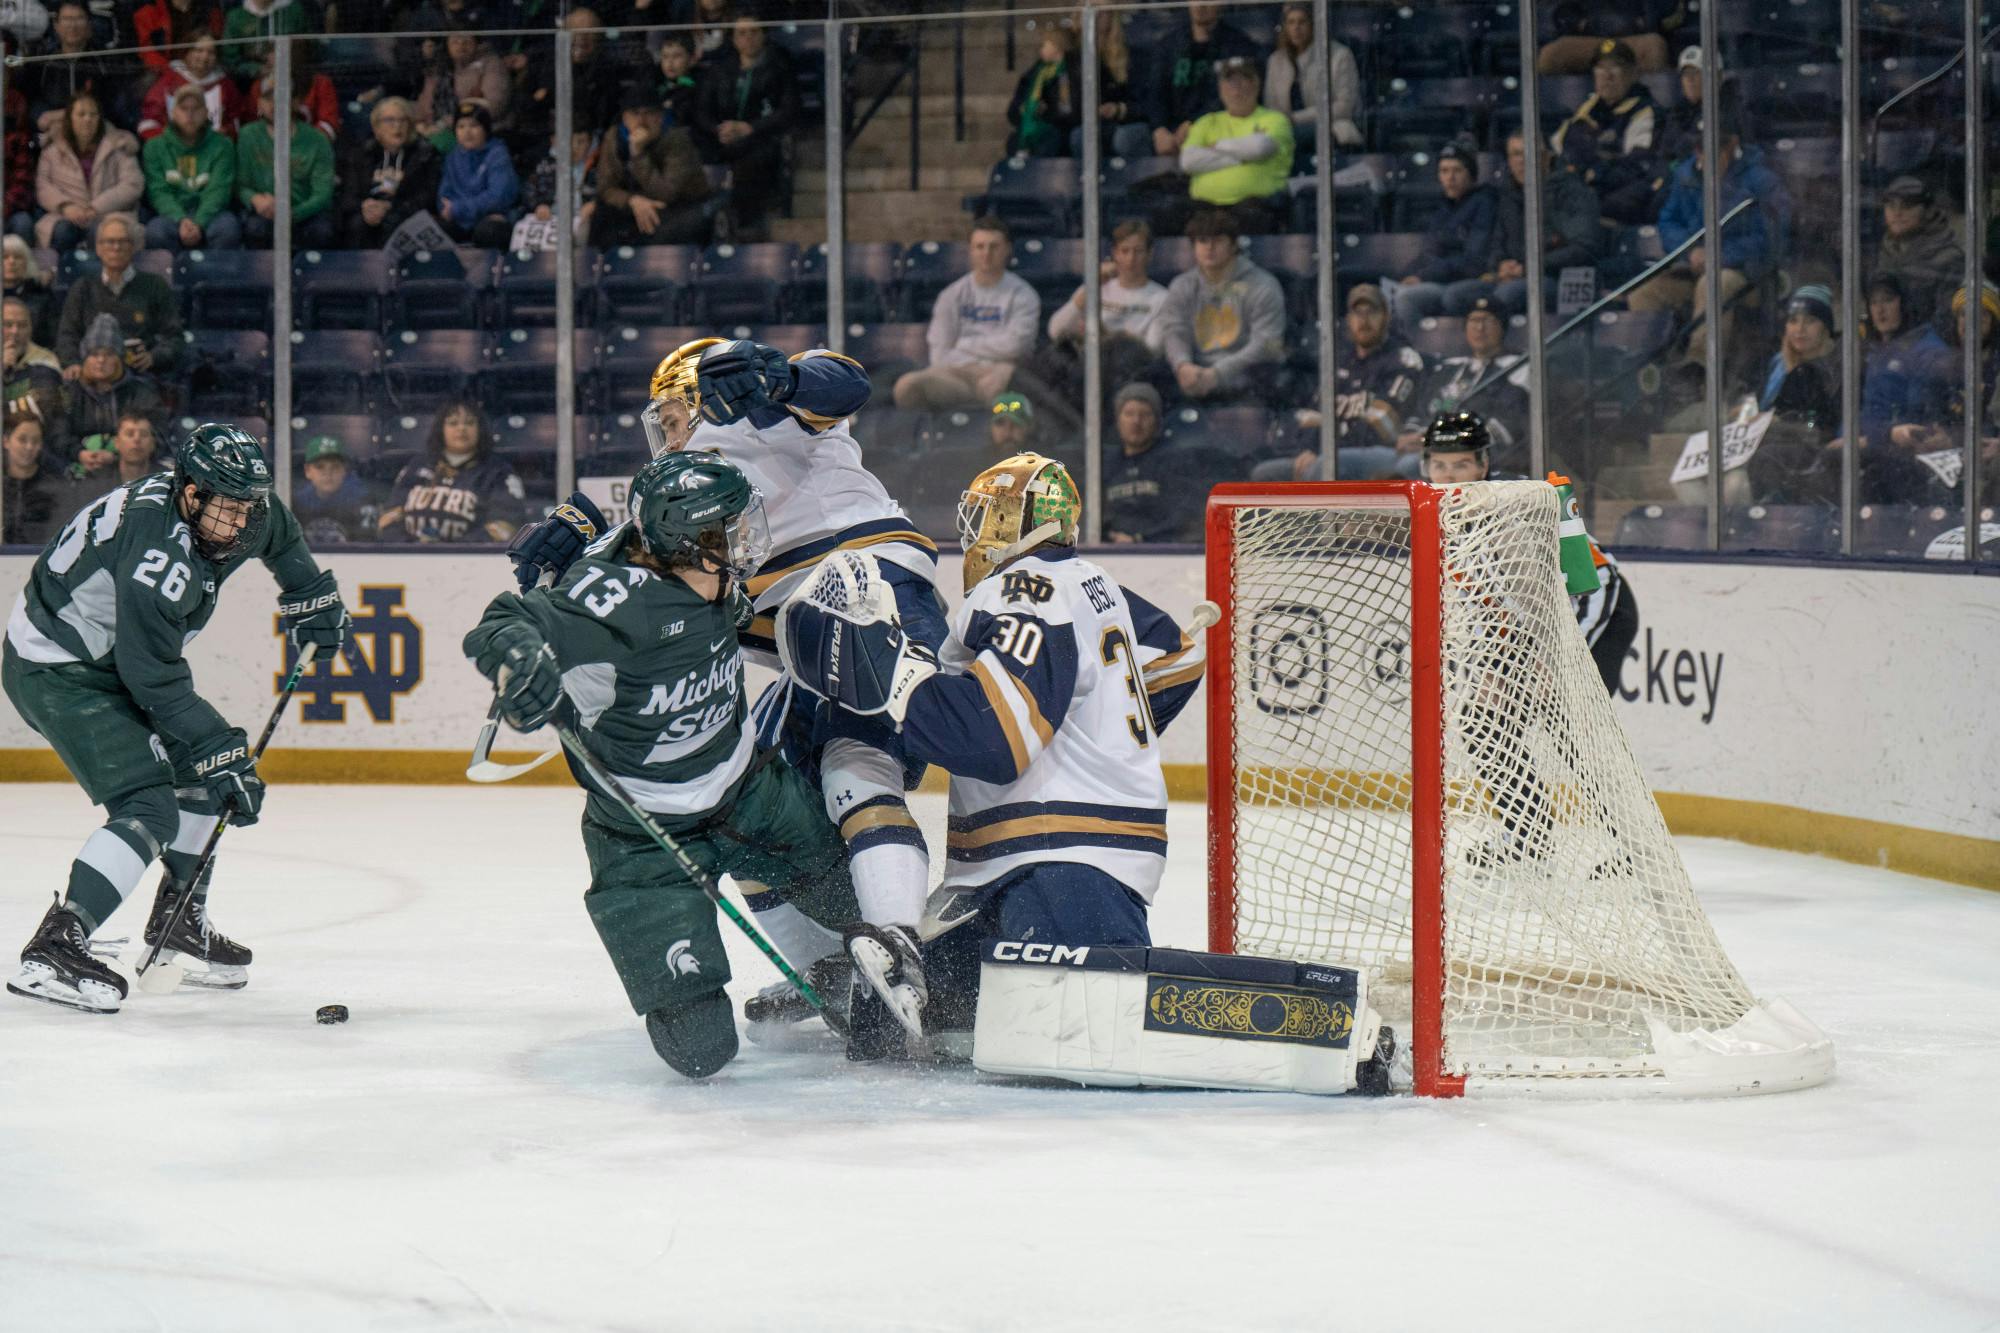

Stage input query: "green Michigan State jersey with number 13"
[{"left": 464, "top": 524, "right": 752, "bottom": 827}]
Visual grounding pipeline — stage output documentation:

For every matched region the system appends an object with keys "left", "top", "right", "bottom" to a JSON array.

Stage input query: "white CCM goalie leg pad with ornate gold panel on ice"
[{"left": 972, "top": 941, "right": 1394, "bottom": 1095}]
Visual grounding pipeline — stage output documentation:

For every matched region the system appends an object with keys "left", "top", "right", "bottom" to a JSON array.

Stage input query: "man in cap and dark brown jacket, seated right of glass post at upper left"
[{"left": 590, "top": 80, "right": 710, "bottom": 248}]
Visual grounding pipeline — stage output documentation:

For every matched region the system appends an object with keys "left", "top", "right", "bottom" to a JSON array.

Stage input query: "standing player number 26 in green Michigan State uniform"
[{"left": 0, "top": 424, "right": 348, "bottom": 1013}]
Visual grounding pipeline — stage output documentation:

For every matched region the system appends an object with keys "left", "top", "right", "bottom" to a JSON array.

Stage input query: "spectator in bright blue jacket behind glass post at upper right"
[{"left": 1626, "top": 111, "right": 1790, "bottom": 362}]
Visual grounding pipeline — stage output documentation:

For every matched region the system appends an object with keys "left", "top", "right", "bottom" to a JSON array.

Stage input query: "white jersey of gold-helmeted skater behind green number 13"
[{"left": 688, "top": 350, "right": 938, "bottom": 667}]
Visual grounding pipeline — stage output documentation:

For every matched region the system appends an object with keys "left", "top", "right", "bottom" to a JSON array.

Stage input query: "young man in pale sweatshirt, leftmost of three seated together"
[{"left": 894, "top": 216, "right": 1042, "bottom": 412}]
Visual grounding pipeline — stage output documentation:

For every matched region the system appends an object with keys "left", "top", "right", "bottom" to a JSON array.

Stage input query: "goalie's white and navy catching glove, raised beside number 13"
[{"left": 778, "top": 550, "right": 938, "bottom": 727}]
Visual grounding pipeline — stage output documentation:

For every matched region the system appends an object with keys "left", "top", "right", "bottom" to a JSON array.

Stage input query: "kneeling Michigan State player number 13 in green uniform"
[{"left": 464, "top": 452, "right": 860, "bottom": 1079}]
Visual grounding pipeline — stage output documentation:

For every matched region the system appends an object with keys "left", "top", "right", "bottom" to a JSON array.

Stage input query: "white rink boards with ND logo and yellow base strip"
[{"left": 0, "top": 550, "right": 2000, "bottom": 889}]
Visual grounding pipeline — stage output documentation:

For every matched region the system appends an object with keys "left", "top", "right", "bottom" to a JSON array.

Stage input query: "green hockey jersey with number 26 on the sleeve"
[{"left": 6, "top": 472, "right": 320, "bottom": 749}]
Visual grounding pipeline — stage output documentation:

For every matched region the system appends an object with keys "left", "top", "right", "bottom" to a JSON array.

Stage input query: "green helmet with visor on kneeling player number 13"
[{"left": 632, "top": 452, "right": 770, "bottom": 580}]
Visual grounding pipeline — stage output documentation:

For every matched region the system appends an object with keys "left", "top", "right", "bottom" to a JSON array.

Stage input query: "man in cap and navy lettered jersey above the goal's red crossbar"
[{"left": 1250, "top": 282, "right": 1424, "bottom": 480}]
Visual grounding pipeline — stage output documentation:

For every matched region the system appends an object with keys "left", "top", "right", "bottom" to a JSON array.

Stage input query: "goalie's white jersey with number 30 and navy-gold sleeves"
[{"left": 904, "top": 548, "right": 1204, "bottom": 903}]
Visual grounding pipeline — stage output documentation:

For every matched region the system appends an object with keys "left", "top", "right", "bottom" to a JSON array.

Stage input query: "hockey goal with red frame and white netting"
[{"left": 1208, "top": 482, "right": 1832, "bottom": 1095}]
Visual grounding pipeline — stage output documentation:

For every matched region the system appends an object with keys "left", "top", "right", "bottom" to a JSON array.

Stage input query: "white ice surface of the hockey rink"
[{"left": 0, "top": 785, "right": 2000, "bottom": 1333}]
